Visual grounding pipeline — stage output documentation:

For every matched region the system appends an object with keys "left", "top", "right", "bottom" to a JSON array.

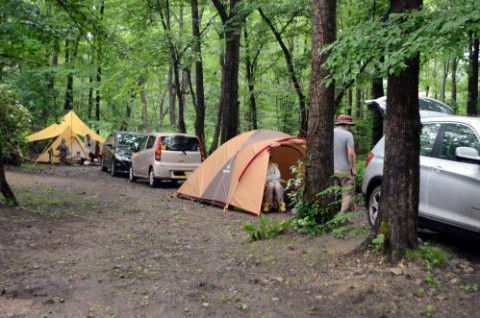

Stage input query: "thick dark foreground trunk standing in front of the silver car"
[{"left": 376, "top": 0, "right": 422, "bottom": 263}]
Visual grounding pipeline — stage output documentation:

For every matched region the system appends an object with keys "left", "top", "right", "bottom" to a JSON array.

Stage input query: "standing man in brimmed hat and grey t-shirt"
[{"left": 333, "top": 115, "right": 357, "bottom": 213}]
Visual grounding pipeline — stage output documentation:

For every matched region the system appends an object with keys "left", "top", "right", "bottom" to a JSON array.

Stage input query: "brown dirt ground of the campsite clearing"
[{"left": 0, "top": 166, "right": 480, "bottom": 317}]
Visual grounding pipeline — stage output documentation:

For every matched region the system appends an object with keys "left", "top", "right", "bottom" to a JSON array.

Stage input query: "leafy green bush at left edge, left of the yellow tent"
[{"left": 0, "top": 84, "right": 30, "bottom": 158}]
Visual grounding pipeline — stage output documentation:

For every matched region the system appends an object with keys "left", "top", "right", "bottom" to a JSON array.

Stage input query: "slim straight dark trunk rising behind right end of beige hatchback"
[{"left": 191, "top": 0, "right": 205, "bottom": 144}]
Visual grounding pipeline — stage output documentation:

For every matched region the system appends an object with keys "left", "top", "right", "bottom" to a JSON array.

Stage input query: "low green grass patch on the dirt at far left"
[{"left": 7, "top": 187, "right": 93, "bottom": 218}]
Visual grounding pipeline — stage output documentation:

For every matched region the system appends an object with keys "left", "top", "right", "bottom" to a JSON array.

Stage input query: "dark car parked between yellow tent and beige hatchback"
[{"left": 102, "top": 131, "right": 145, "bottom": 176}]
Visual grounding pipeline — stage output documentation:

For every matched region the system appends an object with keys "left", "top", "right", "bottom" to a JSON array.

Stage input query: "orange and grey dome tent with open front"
[{"left": 177, "top": 130, "right": 306, "bottom": 215}]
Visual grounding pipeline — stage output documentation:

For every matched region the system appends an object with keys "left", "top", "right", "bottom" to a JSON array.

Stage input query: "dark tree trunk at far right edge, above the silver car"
[{"left": 467, "top": 32, "right": 479, "bottom": 116}]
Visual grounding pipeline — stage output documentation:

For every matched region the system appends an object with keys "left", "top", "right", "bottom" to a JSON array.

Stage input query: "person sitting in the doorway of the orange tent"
[{"left": 262, "top": 153, "right": 287, "bottom": 212}]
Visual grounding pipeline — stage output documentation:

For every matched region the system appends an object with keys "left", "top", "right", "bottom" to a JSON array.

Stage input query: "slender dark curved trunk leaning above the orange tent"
[{"left": 258, "top": 8, "right": 308, "bottom": 136}]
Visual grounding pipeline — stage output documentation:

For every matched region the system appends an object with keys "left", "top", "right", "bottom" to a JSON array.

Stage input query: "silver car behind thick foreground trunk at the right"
[{"left": 362, "top": 116, "right": 480, "bottom": 234}]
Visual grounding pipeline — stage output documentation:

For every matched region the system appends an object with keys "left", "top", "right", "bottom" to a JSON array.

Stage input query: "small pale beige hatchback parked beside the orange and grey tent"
[{"left": 128, "top": 133, "right": 205, "bottom": 187}]
